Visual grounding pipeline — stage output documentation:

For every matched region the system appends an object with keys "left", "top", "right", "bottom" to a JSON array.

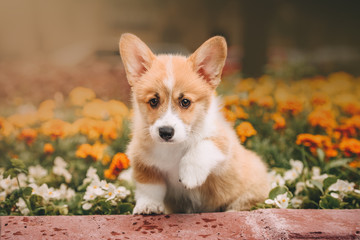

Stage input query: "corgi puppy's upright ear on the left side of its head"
[{"left": 119, "top": 33, "right": 155, "bottom": 86}]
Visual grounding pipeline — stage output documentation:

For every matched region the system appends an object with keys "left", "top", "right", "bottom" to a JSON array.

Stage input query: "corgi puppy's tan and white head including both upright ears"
[{"left": 120, "top": 33, "right": 227, "bottom": 143}]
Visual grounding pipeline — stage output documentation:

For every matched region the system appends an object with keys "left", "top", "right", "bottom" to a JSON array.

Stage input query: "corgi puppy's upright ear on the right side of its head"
[{"left": 188, "top": 36, "right": 227, "bottom": 88}]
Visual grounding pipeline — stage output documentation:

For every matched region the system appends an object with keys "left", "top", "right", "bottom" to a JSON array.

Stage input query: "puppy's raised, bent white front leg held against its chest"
[{"left": 179, "top": 140, "right": 226, "bottom": 189}]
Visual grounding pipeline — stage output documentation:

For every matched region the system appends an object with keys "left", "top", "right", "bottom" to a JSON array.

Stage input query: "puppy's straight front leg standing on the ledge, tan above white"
[{"left": 133, "top": 162, "right": 166, "bottom": 214}]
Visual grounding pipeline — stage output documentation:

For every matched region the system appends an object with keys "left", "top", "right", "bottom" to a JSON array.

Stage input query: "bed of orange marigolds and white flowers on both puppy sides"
[{"left": 0, "top": 73, "right": 360, "bottom": 215}]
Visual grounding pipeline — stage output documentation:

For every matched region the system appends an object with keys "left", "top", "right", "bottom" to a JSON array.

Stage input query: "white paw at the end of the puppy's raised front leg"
[{"left": 179, "top": 161, "right": 209, "bottom": 189}]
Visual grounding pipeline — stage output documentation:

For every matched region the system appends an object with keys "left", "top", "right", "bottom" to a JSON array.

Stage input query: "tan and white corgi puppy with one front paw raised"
[{"left": 119, "top": 33, "right": 269, "bottom": 214}]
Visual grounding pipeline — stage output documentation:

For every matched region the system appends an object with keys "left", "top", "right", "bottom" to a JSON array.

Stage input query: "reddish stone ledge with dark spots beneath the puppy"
[{"left": 0, "top": 209, "right": 360, "bottom": 240}]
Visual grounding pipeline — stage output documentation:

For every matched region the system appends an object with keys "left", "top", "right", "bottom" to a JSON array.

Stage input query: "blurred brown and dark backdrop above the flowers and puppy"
[{"left": 0, "top": 0, "right": 360, "bottom": 105}]
